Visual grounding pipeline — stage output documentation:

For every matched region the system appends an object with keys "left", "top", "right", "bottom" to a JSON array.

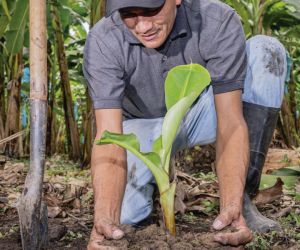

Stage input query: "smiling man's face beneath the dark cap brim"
[{"left": 120, "top": 0, "right": 182, "bottom": 49}]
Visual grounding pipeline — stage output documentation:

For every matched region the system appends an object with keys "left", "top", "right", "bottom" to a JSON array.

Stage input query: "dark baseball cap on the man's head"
[{"left": 106, "top": 0, "right": 165, "bottom": 16}]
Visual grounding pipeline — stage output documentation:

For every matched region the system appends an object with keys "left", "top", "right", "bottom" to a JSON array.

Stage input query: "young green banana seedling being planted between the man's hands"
[{"left": 96, "top": 64, "right": 211, "bottom": 236}]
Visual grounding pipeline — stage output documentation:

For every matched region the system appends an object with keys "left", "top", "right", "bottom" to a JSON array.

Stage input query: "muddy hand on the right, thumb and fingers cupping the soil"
[{"left": 213, "top": 206, "right": 252, "bottom": 246}]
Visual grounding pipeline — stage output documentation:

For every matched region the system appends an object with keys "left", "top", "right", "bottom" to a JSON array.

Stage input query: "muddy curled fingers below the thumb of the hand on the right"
[{"left": 214, "top": 227, "right": 252, "bottom": 246}]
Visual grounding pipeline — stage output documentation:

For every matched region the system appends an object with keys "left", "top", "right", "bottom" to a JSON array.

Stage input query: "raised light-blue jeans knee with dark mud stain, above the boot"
[{"left": 243, "top": 35, "right": 287, "bottom": 108}]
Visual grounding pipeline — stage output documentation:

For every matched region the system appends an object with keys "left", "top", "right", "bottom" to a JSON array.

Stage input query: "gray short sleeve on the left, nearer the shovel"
[{"left": 83, "top": 33, "right": 125, "bottom": 109}]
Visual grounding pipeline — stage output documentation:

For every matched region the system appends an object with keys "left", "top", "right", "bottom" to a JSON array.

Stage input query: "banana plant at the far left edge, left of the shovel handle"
[{"left": 0, "top": 0, "right": 29, "bottom": 156}]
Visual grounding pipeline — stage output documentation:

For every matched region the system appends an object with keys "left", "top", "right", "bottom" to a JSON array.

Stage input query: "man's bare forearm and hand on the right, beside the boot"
[{"left": 213, "top": 90, "right": 252, "bottom": 245}]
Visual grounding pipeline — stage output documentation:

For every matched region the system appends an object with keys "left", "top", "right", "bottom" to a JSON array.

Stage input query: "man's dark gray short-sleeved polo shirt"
[{"left": 83, "top": 0, "right": 247, "bottom": 119}]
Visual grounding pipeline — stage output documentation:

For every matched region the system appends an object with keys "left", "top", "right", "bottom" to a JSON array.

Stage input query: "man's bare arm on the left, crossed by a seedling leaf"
[{"left": 88, "top": 109, "right": 127, "bottom": 250}]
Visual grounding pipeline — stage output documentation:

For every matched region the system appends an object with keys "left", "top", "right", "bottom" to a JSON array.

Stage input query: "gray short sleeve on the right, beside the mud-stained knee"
[{"left": 205, "top": 10, "right": 247, "bottom": 94}]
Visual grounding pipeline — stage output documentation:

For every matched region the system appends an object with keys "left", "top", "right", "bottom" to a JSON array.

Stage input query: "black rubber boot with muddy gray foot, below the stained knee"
[{"left": 243, "top": 102, "right": 281, "bottom": 232}]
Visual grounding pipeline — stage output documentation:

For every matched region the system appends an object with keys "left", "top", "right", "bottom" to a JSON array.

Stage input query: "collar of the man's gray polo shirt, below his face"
[{"left": 120, "top": 5, "right": 188, "bottom": 44}]
